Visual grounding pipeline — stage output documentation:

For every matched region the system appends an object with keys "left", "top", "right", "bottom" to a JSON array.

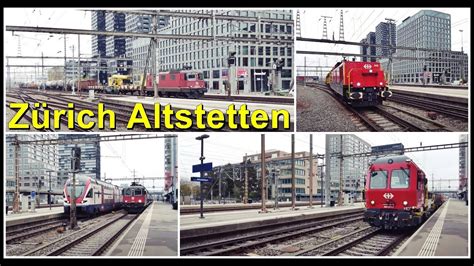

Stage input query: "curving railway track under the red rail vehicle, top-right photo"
[{"left": 312, "top": 83, "right": 451, "bottom": 132}]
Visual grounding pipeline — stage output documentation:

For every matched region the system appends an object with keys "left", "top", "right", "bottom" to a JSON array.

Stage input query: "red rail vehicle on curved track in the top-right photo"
[{"left": 326, "top": 60, "right": 392, "bottom": 107}]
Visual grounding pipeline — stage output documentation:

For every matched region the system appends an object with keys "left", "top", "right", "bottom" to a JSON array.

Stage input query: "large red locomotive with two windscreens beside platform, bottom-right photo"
[{"left": 364, "top": 155, "right": 443, "bottom": 229}]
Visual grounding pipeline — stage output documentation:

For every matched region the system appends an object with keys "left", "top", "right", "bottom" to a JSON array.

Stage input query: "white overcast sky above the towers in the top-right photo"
[{"left": 296, "top": 8, "right": 471, "bottom": 70}]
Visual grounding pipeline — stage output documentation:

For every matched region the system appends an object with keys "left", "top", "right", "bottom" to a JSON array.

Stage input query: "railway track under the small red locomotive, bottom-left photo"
[{"left": 22, "top": 212, "right": 139, "bottom": 256}]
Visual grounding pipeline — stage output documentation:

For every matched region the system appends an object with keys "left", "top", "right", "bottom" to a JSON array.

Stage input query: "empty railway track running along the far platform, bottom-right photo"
[{"left": 180, "top": 212, "right": 363, "bottom": 256}]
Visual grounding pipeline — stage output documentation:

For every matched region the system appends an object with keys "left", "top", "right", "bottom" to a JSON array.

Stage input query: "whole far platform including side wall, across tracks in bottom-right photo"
[{"left": 180, "top": 203, "right": 365, "bottom": 236}]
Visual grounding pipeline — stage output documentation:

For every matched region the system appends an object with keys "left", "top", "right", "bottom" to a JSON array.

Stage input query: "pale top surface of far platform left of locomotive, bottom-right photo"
[{"left": 180, "top": 203, "right": 365, "bottom": 232}]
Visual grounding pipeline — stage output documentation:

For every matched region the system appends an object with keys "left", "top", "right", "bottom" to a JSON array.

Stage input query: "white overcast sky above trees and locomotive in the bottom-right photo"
[{"left": 178, "top": 132, "right": 468, "bottom": 188}]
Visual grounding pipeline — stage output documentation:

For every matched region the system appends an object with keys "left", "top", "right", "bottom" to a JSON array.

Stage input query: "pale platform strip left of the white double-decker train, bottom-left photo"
[{"left": 4, "top": 207, "right": 64, "bottom": 227}]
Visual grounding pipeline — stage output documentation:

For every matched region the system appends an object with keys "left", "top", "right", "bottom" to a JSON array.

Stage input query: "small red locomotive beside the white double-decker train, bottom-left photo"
[{"left": 122, "top": 182, "right": 153, "bottom": 213}]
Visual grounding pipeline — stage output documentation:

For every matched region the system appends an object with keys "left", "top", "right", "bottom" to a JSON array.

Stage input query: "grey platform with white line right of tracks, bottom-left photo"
[{"left": 105, "top": 201, "right": 178, "bottom": 256}]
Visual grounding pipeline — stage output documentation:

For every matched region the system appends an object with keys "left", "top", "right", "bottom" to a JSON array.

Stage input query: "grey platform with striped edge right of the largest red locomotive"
[{"left": 393, "top": 199, "right": 470, "bottom": 257}]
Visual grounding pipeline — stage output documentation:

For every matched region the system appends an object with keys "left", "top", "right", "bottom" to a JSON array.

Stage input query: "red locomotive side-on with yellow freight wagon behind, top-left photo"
[{"left": 145, "top": 70, "right": 207, "bottom": 99}]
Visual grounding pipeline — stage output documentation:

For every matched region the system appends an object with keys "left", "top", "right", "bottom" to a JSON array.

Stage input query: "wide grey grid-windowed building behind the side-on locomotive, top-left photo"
[{"left": 157, "top": 10, "right": 293, "bottom": 93}]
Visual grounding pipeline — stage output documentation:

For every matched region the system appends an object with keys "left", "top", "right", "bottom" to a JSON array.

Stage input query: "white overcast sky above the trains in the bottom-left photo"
[{"left": 100, "top": 135, "right": 165, "bottom": 190}]
